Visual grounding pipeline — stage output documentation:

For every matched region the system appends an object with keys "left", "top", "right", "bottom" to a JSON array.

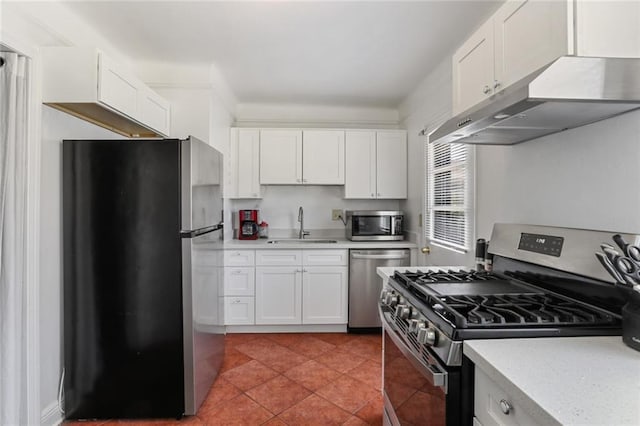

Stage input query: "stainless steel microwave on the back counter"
[{"left": 345, "top": 210, "right": 404, "bottom": 241}]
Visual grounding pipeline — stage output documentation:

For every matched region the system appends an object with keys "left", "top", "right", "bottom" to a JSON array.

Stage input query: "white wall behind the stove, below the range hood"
[{"left": 477, "top": 111, "right": 640, "bottom": 238}]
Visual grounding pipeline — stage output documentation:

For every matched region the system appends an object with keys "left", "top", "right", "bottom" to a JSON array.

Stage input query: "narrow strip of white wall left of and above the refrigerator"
[{"left": 40, "top": 106, "right": 122, "bottom": 421}]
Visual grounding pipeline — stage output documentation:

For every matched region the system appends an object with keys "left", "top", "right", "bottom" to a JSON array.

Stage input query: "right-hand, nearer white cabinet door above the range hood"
[{"left": 494, "top": 0, "right": 569, "bottom": 91}]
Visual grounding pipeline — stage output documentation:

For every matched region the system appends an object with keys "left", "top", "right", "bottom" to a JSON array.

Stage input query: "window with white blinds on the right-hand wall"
[{"left": 425, "top": 142, "right": 474, "bottom": 251}]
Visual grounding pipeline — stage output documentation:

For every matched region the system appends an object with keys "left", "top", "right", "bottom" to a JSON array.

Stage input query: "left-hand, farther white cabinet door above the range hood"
[{"left": 453, "top": 19, "right": 494, "bottom": 115}]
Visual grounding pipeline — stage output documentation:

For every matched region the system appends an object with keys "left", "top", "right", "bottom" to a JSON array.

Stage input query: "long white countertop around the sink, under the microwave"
[{"left": 224, "top": 237, "right": 417, "bottom": 250}]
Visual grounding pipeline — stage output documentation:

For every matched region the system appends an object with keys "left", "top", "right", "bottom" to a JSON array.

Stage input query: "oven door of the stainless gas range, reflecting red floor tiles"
[{"left": 380, "top": 311, "right": 466, "bottom": 426}]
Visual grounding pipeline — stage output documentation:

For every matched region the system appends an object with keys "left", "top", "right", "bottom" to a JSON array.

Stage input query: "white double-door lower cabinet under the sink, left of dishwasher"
[{"left": 255, "top": 250, "right": 348, "bottom": 325}]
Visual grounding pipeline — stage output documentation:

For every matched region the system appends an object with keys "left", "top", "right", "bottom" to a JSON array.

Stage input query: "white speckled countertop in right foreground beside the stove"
[{"left": 463, "top": 336, "right": 640, "bottom": 426}]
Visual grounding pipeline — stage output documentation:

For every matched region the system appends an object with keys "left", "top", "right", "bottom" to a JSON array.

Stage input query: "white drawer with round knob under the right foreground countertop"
[{"left": 473, "top": 368, "right": 539, "bottom": 426}]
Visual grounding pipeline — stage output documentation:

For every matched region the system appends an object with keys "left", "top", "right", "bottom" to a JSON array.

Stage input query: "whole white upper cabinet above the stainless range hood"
[{"left": 452, "top": 0, "right": 640, "bottom": 115}]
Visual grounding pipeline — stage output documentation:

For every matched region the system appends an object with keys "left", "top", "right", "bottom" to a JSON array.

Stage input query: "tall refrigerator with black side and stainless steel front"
[{"left": 63, "top": 138, "right": 224, "bottom": 419}]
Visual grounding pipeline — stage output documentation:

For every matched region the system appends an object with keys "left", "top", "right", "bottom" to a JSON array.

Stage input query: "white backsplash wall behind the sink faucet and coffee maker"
[{"left": 230, "top": 185, "right": 400, "bottom": 236}]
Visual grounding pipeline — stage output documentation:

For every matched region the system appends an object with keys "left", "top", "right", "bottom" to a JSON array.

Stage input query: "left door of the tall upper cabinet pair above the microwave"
[{"left": 344, "top": 130, "right": 376, "bottom": 198}]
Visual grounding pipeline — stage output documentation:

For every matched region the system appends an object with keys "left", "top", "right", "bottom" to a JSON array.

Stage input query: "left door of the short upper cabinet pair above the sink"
[{"left": 260, "top": 130, "right": 302, "bottom": 185}]
